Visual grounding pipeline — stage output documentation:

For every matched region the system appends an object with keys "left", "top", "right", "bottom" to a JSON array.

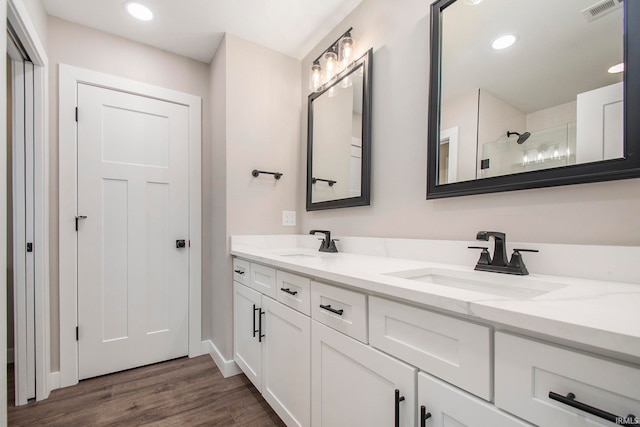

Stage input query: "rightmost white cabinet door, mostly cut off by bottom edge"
[{"left": 417, "top": 372, "right": 530, "bottom": 427}]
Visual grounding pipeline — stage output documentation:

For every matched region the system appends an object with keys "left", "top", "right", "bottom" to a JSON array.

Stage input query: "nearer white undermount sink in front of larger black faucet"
[{"left": 385, "top": 268, "right": 566, "bottom": 299}]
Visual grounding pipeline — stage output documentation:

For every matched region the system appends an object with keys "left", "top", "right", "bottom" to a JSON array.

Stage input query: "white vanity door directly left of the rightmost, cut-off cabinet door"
[{"left": 311, "top": 320, "right": 416, "bottom": 427}]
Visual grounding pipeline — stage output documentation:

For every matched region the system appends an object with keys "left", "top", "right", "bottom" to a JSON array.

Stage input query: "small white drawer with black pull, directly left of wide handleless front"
[{"left": 311, "top": 281, "right": 367, "bottom": 344}]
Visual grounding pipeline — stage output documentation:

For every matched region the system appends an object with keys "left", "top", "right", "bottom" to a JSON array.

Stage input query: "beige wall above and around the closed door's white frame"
[{"left": 47, "top": 17, "right": 211, "bottom": 371}]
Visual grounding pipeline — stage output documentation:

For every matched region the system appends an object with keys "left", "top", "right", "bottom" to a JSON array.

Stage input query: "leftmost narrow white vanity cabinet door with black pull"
[{"left": 233, "top": 282, "right": 264, "bottom": 390}]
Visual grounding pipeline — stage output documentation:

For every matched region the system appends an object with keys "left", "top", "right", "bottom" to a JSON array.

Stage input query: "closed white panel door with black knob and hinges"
[{"left": 78, "top": 84, "right": 189, "bottom": 379}]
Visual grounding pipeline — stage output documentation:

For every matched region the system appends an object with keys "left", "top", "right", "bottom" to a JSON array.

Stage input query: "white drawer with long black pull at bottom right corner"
[{"left": 495, "top": 332, "right": 640, "bottom": 427}]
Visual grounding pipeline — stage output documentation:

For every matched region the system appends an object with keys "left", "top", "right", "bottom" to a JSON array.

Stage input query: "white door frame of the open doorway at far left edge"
[{"left": 0, "top": 0, "right": 51, "bottom": 408}]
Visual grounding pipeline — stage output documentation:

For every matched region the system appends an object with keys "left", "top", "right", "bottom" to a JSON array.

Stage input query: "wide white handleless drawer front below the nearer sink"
[{"left": 369, "top": 297, "right": 492, "bottom": 400}]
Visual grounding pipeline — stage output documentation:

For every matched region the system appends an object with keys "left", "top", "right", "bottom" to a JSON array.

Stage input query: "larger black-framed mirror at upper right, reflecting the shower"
[{"left": 427, "top": 0, "right": 640, "bottom": 199}]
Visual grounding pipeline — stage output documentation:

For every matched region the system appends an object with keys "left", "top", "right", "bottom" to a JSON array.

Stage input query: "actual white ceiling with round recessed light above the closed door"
[{"left": 42, "top": 0, "right": 362, "bottom": 63}]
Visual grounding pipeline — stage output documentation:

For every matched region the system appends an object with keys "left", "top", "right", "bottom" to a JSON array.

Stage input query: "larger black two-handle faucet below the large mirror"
[{"left": 469, "top": 231, "right": 538, "bottom": 276}]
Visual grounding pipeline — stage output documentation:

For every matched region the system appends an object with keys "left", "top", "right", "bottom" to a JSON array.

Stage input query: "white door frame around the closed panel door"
[{"left": 58, "top": 64, "right": 202, "bottom": 387}]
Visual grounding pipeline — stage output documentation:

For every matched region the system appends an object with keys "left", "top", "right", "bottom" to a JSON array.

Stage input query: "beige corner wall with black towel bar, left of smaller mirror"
[{"left": 211, "top": 34, "right": 300, "bottom": 360}]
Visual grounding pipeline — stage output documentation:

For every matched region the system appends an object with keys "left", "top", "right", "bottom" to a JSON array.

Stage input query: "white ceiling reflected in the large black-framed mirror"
[{"left": 441, "top": 0, "right": 623, "bottom": 114}]
